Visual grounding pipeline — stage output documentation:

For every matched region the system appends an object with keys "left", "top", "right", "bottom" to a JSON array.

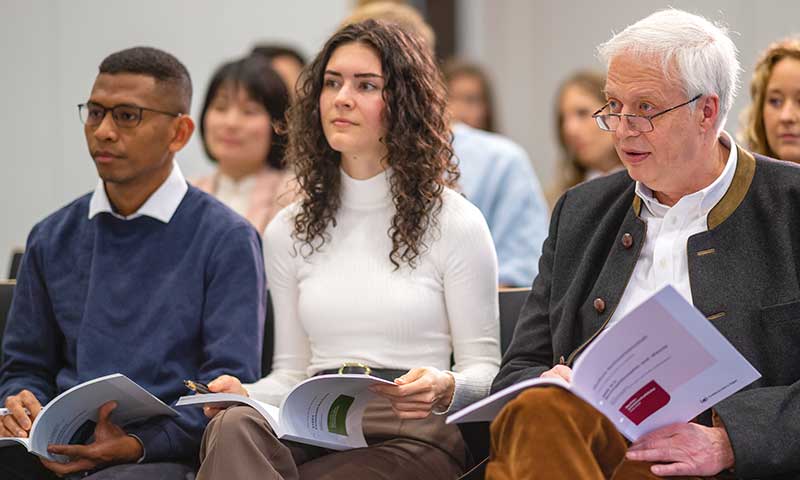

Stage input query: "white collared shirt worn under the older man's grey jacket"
[{"left": 611, "top": 132, "right": 738, "bottom": 323}]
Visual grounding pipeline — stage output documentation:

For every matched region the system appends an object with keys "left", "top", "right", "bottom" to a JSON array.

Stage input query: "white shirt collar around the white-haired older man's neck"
[{"left": 636, "top": 131, "right": 739, "bottom": 217}]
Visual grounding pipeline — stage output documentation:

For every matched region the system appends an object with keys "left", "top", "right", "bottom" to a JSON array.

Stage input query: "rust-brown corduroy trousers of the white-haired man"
[{"left": 486, "top": 387, "right": 723, "bottom": 480}]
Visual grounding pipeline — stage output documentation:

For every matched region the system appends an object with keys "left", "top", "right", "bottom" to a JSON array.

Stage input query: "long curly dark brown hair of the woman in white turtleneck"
[{"left": 287, "top": 20, "right": 459, "bottom": 269}]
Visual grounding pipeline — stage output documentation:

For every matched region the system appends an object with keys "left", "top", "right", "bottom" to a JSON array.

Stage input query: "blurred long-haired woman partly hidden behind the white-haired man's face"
[{"left": 547, "top": 70, "right": 623, "bottom": 205}]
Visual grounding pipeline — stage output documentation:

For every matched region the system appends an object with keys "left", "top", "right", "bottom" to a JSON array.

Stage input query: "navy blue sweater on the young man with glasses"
[{"left": 0, "top": 187, "right": 266, "bottom": 462}]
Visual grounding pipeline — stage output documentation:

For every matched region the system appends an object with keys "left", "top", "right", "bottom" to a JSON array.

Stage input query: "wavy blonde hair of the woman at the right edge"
[{"left": 740, "top": 37, "right": 800, "bottom": 158}]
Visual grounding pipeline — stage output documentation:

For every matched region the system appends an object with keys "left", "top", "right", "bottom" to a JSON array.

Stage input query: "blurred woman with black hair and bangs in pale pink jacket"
[{"left": 193, "top": 56, "right": 294, "bottom": 233}]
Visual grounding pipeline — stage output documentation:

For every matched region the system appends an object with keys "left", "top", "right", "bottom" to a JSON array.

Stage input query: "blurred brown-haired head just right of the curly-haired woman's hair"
[{"left": 442, "top": 59, "right": 497, "bottom": 132}]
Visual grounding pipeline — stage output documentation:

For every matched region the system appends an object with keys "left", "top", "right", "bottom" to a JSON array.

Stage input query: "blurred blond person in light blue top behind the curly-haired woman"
[{"left": 342, "top": 1, "right": 548, "bottom": 287}]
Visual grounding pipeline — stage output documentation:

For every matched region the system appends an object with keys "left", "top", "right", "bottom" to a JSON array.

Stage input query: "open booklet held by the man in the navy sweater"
[{"left": 0, "top": 373, "right": 178, "bottom": 462}]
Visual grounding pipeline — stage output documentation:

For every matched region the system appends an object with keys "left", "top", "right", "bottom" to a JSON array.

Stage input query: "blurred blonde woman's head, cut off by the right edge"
[{"left": 742, "top": 37, "right": 800, "bottom": 163}]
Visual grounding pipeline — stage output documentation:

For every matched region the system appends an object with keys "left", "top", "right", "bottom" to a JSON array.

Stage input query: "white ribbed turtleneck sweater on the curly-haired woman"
[{"left": 246, "top": 170, "right": 500, "bottom": 411}]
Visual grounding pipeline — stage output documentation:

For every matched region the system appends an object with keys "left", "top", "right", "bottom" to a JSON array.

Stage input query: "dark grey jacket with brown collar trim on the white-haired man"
[{"left": 492, "top": 147, "right": 800, "bottom": 478}]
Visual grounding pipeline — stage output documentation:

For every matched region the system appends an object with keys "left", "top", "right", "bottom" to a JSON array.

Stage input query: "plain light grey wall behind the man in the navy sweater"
[{"left": 0, "top": 0, "right": 351, "bottom": 278}]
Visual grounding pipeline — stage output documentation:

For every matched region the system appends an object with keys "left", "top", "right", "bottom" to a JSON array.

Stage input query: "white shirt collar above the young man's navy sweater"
[{"left": 89, "top": 162, "right": 189, "bottom": 223}]
